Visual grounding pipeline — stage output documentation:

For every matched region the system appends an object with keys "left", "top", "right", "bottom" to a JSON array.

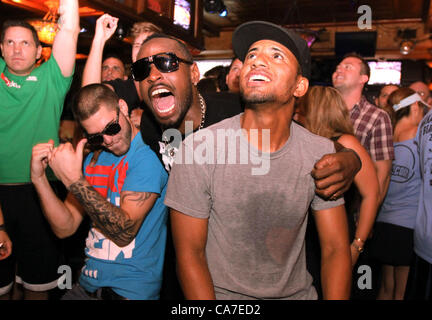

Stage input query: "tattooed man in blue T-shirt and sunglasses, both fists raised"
[{"left": 31, "top": 84, "right": 168, "bottom": 300}]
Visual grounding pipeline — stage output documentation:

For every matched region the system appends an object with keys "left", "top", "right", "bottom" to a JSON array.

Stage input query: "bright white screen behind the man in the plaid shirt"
[{"left": 368, "top": 61, "right": 402, "bottom": 85}]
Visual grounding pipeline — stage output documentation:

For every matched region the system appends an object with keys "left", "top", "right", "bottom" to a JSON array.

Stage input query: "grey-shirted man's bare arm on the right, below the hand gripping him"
[{"left": 314, "top": 205, "right": 351, "bottom": 300}]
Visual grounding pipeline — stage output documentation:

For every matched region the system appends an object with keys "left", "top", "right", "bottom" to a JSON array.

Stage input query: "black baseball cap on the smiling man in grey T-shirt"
[{"left": 232, "top": 21, "right": 311, "bottom": 79}]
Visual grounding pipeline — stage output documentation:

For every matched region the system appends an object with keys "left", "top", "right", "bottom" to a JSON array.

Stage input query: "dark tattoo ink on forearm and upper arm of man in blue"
[{"left": 69, "top": 178, "right": 151, "bottom": 246}]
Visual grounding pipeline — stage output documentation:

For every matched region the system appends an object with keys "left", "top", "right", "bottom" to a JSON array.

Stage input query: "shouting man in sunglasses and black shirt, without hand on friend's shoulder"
[{"left": 132, "top": 33, "right": 242, "bottom": 171}]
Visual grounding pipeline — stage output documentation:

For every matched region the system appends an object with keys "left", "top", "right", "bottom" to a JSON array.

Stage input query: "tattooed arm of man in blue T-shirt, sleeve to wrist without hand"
[{"left": 69, "top": 178, "right": 158, "bottom": 247}]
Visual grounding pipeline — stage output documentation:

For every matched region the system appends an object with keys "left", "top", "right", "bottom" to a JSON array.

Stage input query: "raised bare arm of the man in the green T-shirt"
[{"left": 52, "top": 0, "right": 79, "bottom": 77}]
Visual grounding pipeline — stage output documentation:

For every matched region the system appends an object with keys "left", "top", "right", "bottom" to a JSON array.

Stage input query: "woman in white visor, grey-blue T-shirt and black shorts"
[{"left": 371, "top": 88, "right": 428, "bottom": 300}]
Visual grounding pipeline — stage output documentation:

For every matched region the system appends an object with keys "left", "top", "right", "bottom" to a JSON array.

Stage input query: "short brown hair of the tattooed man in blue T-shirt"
[{"left": 72, "top": 83, "right": 119, "bottom": 122}]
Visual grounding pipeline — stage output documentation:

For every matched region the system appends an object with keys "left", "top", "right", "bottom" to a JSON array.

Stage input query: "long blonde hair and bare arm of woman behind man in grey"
[{"left": 297, "top": 86, "right": 379, "bottom": 266}]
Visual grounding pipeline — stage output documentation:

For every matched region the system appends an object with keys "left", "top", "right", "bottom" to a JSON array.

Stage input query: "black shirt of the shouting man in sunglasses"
[{"left": 140, "top": 92, "right": 244, "bottom": 169}]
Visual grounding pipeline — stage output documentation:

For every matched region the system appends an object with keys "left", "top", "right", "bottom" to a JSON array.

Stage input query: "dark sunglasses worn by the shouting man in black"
[{"left": 132, "top": 52, "right": 193, "bottom": 81}]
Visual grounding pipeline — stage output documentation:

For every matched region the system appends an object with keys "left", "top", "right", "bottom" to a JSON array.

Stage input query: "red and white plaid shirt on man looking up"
[{"left": 350, "top": 96, "right": 394, "bottom": 161}]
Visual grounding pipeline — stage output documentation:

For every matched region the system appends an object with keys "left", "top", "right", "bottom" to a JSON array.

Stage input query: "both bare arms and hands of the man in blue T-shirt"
[{"left": 31, "top": 139, "right": 158, "bottom": 247}]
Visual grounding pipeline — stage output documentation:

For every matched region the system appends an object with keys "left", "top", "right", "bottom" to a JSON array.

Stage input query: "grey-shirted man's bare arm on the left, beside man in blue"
[{"left": 171, "top": 209, "right": 216, "bottom": 300}]
